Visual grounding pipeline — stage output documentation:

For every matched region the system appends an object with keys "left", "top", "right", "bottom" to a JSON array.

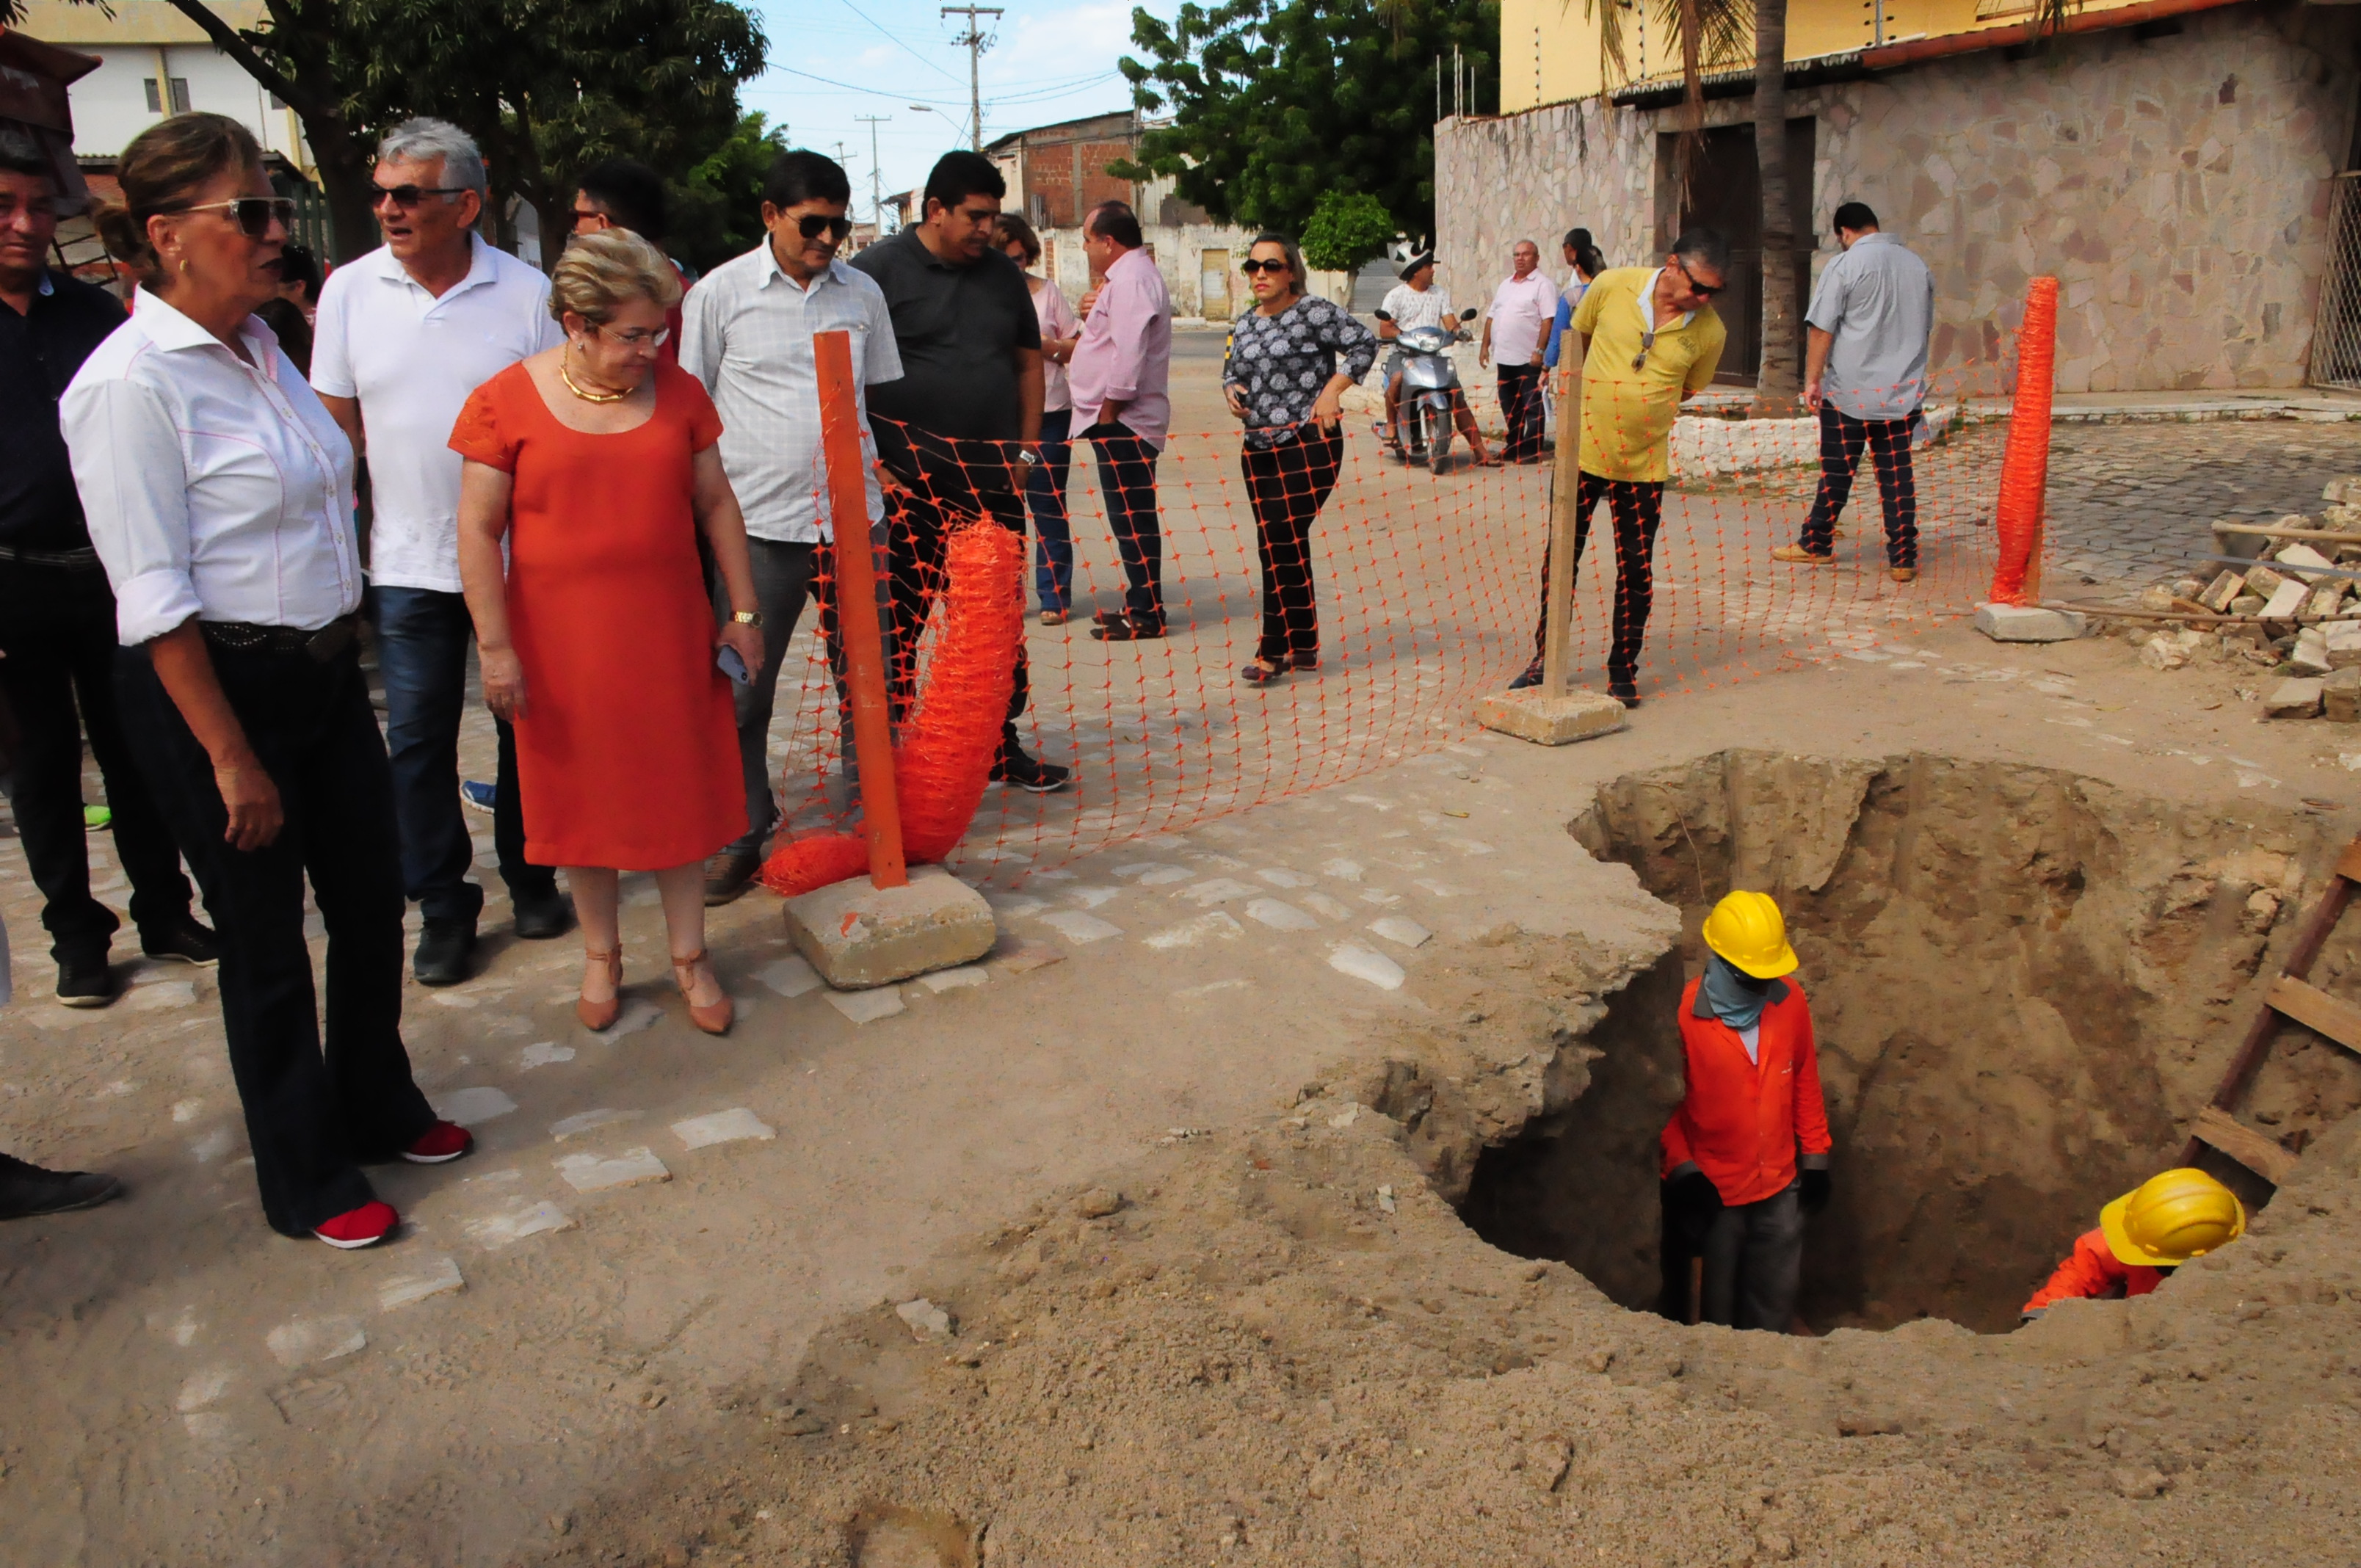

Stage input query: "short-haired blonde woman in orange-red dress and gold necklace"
[{"left": 451, "top": 229, "right": 763, "bottom": 1034}]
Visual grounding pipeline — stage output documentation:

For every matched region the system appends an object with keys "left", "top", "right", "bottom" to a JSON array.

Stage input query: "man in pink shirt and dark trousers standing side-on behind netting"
[{"left": 1067, "top": 200, "right": 1173, "bottom": 642}]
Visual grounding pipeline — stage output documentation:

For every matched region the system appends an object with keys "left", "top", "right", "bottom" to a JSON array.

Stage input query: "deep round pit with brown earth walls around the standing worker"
[{"left": 1464, "top": 751, "right": 2361, "bottom": 1332}]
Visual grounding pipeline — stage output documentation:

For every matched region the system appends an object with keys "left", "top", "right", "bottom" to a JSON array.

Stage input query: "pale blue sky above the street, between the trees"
[{"left": 739, "top": 0, "right": 1173, "bottom": 217}]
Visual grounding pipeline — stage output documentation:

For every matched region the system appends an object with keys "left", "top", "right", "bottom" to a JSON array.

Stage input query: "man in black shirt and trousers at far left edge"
[{"left": 0, "top": 130, "right": 215, "bottom": 1009}]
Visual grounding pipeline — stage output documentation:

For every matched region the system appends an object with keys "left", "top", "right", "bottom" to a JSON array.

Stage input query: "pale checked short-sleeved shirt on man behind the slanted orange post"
[{"left": 680, "top": 239, "right": 902, "bottom": 543}]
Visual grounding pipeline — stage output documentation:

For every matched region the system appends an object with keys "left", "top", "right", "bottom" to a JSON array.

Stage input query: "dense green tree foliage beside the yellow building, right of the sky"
[{"left": 1114, "top": 0, "right": 1499, "bottom": 236}]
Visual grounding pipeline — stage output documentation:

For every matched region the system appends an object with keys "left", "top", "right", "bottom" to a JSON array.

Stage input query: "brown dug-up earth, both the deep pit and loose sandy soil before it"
[{"left": 540, "top": 753, "right": 2361, "bottom": 1568}]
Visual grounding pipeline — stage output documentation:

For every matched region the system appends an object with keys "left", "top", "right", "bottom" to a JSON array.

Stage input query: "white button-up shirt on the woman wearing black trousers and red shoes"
[{"left": 59, "top": 291, "right": 361, "bottom": 647}]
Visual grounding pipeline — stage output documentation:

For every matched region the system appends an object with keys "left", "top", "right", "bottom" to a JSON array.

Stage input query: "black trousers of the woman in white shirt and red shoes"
[{"left": 116, "top": 650, "right": 435, "bottom": 1235}]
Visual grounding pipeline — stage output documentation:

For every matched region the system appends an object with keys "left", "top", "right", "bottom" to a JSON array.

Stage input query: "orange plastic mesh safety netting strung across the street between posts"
[{"left": 746, "top": 342, "right": 2047, "bottom": 885}]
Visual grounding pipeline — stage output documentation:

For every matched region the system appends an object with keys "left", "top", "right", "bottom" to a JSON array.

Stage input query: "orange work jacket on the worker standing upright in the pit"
[{"left": 1662, "top": 976, "right": 1829, "bottom": 1205}]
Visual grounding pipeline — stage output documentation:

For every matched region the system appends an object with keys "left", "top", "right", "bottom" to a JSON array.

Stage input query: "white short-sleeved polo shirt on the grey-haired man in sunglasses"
[{"left": 312, "top": 233, "right": 565, "bottom": 592}]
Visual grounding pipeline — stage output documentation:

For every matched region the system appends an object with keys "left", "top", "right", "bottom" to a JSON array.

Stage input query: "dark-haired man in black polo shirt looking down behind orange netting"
[{"left": 852, "top": 153, "right": 1072, "bottom": 794}]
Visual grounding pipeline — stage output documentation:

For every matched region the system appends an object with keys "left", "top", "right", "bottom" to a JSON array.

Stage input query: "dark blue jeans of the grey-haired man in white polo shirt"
[{"left": 375, "top": 588, "right": 557, "bottom": 928}]
